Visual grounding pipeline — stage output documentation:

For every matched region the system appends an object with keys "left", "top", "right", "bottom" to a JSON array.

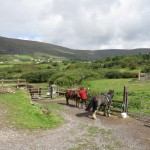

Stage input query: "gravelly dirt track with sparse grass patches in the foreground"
[{"left": 0, "top": 100, "right": 150, "bottom": 150}]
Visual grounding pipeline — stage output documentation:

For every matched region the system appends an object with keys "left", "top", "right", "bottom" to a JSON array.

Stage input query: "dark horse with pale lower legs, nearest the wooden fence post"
[{"left": 85, "top": 90, "right": 114, "bottom": 119}]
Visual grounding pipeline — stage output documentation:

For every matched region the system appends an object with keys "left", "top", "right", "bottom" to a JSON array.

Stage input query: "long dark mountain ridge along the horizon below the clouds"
[{"left": 0, "top": 36, "right": 150, "bottom": 60}]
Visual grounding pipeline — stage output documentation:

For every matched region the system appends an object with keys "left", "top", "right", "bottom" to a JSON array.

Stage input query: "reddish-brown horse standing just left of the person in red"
[{"left": 65, "top": 89, "right": 80, "bottom": 107}]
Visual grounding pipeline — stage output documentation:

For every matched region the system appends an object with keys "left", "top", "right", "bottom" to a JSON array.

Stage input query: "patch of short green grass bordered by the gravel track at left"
[{"left": 0, "top": 91, "right": 64, "bottom": 129}]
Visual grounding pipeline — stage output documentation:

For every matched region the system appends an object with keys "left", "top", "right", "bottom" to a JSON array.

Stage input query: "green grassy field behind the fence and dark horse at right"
[{"left": 83, "top": 79, "right": 150, "bottom": 115}]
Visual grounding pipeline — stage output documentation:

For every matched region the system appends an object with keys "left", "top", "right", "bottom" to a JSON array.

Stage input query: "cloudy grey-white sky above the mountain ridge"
[{"left": 0, "top": 0, "right": 150, "bottom": 50}]
